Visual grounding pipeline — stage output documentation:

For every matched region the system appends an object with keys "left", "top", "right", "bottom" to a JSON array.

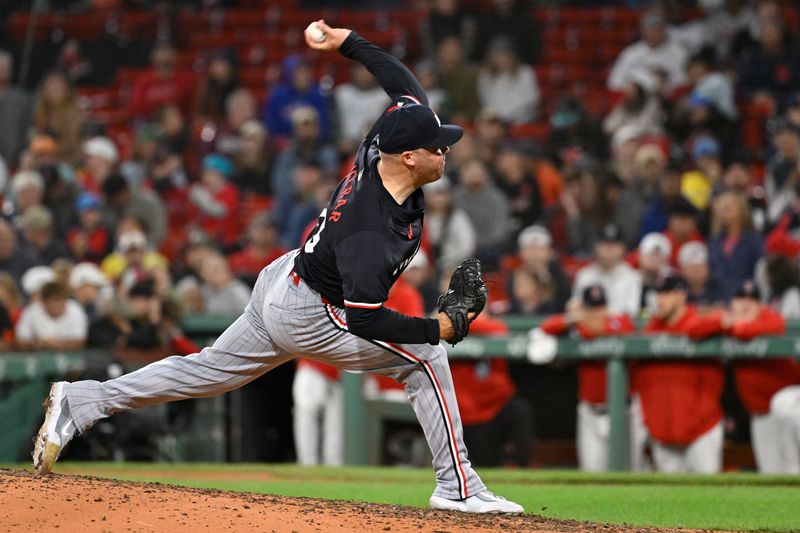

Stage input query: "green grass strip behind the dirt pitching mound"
[{"left": 14, "top": 463, "right": 800, "bottom": 531}]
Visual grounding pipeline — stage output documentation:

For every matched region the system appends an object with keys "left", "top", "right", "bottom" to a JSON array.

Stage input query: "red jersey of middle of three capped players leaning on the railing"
[{"left": 633, "top": 306, "right": 725, "bottom": 446}]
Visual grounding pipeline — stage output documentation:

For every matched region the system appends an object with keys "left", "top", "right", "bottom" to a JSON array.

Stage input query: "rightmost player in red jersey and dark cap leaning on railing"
[{"left": 690, "top": 280, "right": 800, "bottom": 474}]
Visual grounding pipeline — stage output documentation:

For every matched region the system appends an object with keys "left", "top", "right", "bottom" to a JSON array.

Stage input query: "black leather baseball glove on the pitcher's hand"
[{"left": 439, "top": 259, "right": 487, "bottom": 346}]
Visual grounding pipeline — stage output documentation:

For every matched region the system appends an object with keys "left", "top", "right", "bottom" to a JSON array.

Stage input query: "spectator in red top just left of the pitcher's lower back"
[{"left": 228, "top": 213, "right": 287, "bottom": 287}]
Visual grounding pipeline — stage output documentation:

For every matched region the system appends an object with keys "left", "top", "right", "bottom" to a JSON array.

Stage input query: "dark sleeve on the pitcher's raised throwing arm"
[{"left": 339, "top": 32, "right": 428, "bottom": 105}]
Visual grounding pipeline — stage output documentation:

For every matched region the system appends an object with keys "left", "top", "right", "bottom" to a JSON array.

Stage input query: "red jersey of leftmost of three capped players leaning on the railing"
[{"left": 540, "top": 314, "right": 636, "bottom": 405}]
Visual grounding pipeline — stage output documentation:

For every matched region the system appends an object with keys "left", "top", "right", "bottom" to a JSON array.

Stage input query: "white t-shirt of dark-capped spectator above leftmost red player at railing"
[{"left": 572, "top": 262, "right": 642, "bottom": 318}]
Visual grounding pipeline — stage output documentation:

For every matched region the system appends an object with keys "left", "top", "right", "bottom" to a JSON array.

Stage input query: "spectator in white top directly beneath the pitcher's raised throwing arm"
[{"left": 333, "top": 62, "right": 388, "bottom": 154}]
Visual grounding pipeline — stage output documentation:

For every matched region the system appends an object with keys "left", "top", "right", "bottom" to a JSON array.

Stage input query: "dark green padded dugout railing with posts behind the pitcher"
[{"left": 0, "top": 316, "right": 800, "bottom": 470}]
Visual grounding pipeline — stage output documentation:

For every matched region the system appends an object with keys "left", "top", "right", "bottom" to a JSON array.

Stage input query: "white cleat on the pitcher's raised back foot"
[{"left": 33, "top": 381, "right": 75, "bottom": 475}]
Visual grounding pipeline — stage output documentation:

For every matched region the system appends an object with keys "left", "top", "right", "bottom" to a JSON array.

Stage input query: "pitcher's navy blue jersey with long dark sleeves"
[{"left": 295, "top": 32, "right": 439, "bottom": 344}]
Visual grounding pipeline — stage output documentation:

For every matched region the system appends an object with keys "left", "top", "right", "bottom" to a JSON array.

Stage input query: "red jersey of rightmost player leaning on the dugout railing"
[{"left": 690, "top": 306, "right": 800, "bottom": 416}]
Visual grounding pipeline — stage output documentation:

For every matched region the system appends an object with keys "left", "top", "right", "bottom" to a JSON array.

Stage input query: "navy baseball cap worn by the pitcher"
[{"left": 378, "top": 104, "right": 464, "bottom": 154}]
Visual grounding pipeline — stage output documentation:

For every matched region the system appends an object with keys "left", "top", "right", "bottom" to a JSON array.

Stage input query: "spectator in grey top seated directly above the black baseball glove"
[{"left": 453, "top": 159, "right": 511, "bottom": 268}]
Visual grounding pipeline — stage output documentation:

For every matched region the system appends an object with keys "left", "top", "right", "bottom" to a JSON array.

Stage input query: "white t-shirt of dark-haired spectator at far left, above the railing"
[{"left": 15, "top": 300, "right": 89, "bottom": 341}]
